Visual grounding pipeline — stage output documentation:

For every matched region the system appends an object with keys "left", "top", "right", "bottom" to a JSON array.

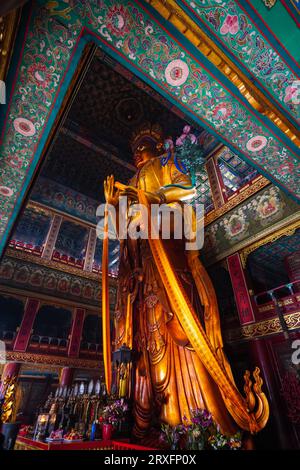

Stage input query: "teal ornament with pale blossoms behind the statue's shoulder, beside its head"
[{"left": 163, "top": 126, "right": 205, "bottom": 185}]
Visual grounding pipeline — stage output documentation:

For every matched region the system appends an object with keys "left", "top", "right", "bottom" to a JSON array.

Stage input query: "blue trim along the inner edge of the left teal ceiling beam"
[{"left": 0, "top": 38, "right": 87, "bottom": 253}]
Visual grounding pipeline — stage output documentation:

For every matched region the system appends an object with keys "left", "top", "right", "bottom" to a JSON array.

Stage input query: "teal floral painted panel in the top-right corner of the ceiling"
[{"left": 182, "top": 0, "right": 300, "bottom": 120}]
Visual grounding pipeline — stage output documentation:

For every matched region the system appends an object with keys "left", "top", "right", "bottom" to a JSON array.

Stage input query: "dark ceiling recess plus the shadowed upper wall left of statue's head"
[{"left": 39, "top": 49, "right": 193, "bottom": 202}]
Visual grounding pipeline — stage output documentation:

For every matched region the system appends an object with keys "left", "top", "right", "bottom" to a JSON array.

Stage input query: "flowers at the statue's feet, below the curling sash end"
[{"left": 161, "top": 408, "right": 242, "bottom": 450}]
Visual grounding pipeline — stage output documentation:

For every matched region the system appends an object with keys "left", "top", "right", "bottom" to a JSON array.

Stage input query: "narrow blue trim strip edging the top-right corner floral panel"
[{"left": 177, "top": 0, "right": 298, "bottom": 129}]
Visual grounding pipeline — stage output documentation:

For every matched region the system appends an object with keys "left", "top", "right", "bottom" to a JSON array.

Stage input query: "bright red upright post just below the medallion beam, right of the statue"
[{"left": 227, "top": 253, "right": 255, "bottom": 325}]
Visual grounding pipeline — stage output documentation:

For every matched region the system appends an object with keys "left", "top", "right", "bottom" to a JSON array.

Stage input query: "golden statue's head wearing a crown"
[{"left": 131, "top": 123, "right": 163, "bottom": 168}]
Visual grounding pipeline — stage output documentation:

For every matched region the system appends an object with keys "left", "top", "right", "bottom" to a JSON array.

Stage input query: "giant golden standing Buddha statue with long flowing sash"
[{"left": 102, "top": 125, "right": 269, "bottom": 437}]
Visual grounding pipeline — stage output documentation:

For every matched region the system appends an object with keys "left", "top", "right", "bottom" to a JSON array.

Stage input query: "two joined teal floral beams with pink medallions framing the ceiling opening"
[{"left": 0, "top": 0, "right": 300, "bottom": 258}]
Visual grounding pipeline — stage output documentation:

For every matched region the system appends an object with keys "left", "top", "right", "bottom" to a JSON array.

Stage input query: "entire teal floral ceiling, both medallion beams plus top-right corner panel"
[{"left": 0, "top": 0, "right": 300, "bottom": 258}]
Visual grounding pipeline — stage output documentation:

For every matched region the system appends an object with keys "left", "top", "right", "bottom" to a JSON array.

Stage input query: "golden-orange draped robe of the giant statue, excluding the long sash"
[{"left": 115, "top": 158, "right": 236, "bottom": 436}]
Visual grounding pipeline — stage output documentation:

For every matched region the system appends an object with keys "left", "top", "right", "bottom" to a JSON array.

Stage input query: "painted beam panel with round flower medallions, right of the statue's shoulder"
[{"left": 203, "top": 186, "right": 299, "bottom": 263}]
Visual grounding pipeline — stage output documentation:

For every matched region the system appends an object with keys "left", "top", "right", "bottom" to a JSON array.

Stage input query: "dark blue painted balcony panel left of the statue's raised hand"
[{"left": 30, "top": 177, "right": 99, "bottom": 224}]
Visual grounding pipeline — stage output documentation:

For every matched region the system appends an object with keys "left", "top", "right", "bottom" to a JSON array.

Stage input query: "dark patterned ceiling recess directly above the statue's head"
[{"left": 68, "top": 49, "right": 195, "bottom": 163}]
